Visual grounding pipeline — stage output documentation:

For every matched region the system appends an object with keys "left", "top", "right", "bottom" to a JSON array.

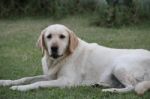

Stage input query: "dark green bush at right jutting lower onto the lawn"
[{"left": 92, "top": 0, "right": 150, "bottom": 27}]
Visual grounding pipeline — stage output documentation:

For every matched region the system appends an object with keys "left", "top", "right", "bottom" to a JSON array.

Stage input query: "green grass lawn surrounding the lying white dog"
[{"left": 0, "top": 16, "right": 150, "bottom": 99}]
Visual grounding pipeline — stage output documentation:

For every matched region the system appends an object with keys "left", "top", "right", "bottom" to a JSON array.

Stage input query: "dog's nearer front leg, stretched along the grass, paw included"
[{"left": 10, "top": 78, "right": 71, "bottom": 91}]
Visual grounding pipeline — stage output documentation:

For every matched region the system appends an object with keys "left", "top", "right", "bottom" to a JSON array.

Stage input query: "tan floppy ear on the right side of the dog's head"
[{"left": 68, "top": 30, "right": 79, "bottom": 54}]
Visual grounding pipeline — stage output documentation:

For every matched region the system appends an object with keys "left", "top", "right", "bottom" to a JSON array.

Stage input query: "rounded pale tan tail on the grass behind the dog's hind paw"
[{"left": 135, "top": 81, "right": 150, "bottom": 95}]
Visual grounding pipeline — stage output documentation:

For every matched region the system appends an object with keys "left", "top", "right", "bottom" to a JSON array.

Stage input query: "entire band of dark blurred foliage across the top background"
[{"left": 0, "top": 0, "right": 150, "bottom": 26}]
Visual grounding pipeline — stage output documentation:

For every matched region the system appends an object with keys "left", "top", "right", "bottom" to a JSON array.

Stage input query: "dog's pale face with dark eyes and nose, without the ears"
[{"left": 44, "top": 25, "right": 69, "bottom": 58}]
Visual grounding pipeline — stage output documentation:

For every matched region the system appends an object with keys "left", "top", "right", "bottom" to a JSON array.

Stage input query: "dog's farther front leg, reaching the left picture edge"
[{"left": 0, "top": 75, "right": 51, "bottom": 86}]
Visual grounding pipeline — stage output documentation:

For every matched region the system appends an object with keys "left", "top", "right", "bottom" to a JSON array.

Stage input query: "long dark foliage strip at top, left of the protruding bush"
[{"left": 0, "top": 0, "right": 98, "bottom": 18}]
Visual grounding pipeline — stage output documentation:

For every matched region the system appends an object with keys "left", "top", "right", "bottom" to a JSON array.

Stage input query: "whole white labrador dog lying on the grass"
[{"left": 0, "top": 24, "right": 150, "bottom": 94}]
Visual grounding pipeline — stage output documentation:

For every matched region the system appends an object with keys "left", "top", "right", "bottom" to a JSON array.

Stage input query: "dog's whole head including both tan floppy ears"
[{"left": 37, "top": 24, "right": 78, "bottom": 59}]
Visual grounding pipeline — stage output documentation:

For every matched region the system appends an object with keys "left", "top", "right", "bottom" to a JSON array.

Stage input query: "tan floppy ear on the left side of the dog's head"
[{"left": 37, "top": 29, "right": 46, "bottom": 55}]
